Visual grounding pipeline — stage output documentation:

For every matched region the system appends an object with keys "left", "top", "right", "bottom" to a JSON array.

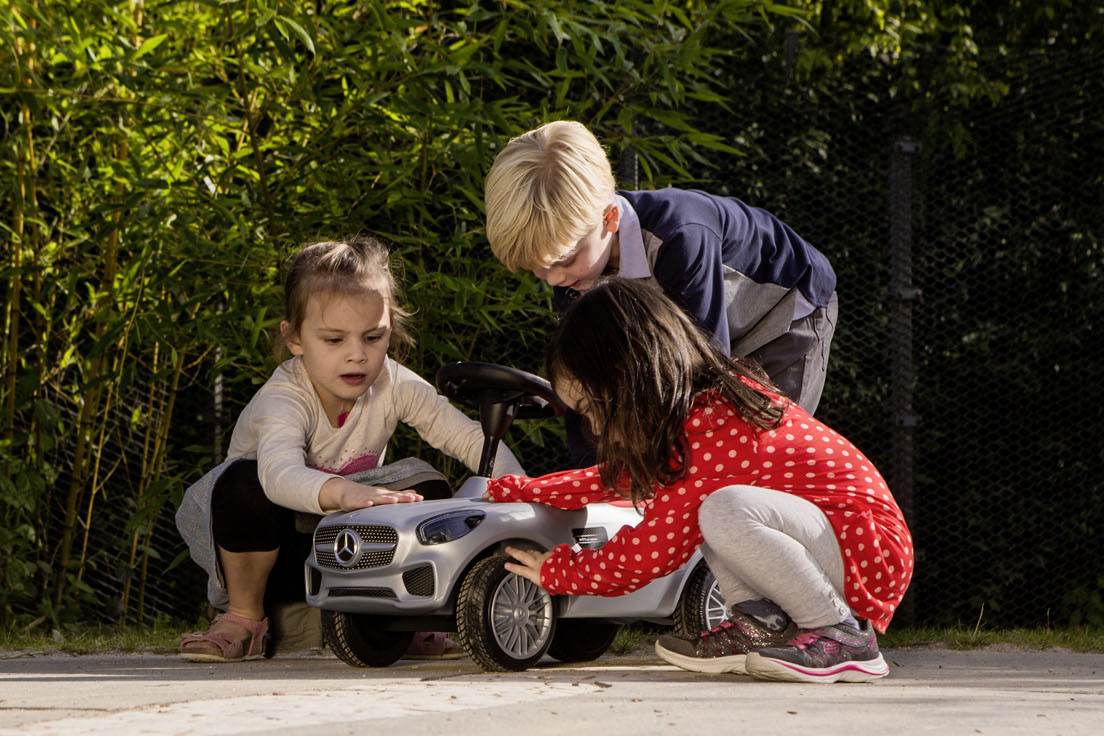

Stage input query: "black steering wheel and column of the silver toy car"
[{"left": 437, "top": 361, "right": 564, "bottom": 477}]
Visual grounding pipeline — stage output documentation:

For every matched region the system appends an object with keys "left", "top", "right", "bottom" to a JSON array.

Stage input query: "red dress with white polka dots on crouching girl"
[{"left": 487, "top": 386, "right": 913, "bottom": 631}]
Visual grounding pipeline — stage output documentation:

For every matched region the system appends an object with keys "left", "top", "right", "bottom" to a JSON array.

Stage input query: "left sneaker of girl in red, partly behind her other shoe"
[{"left": 656, "top": 610, "right": 797, "bottom": 674}]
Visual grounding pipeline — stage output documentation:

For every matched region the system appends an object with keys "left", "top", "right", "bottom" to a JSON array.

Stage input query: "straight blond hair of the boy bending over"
[{"left": 484, "top": 120, "right": 615, "bottom": 271}]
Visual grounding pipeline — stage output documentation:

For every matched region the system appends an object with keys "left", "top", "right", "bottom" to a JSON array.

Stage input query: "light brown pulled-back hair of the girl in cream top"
[{"left": 275, "top": 235, "right": 414, "bottom": 358}]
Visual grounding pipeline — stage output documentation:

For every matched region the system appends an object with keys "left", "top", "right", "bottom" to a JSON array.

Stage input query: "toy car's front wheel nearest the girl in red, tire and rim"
[{"left": 456, "top": 555, "right": 556, "bottom": 672}]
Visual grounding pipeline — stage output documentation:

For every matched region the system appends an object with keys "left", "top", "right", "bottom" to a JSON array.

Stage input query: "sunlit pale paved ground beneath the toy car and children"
[{"left": 0, "top": 648, "right": 1104, "bottom": 736}]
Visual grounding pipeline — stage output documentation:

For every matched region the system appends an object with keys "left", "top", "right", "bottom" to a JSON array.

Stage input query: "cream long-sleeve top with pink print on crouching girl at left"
[{"left": 227, "top": 358, "right": 524, "bottom": 514}]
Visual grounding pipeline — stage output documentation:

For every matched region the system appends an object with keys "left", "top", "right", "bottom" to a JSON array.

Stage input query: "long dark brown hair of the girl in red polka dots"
[{"left": 544, "top": 278, "right": 785, "bottom": 503}]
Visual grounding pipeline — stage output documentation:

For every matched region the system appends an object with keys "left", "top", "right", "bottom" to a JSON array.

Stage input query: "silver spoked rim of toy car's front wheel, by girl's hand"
[{"left": 490, "top": 574, "right": 552, "bottom": 660}]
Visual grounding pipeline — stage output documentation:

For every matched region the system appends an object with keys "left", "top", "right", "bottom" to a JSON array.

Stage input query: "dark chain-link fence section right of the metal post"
[{"left": 913, "top": 51, "right": 1104, "bottom": 626}]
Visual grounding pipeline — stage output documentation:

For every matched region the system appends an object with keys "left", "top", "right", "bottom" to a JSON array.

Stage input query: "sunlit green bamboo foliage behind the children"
[{"left": 0, "top": 0, "right": 794, "bottom": 621}]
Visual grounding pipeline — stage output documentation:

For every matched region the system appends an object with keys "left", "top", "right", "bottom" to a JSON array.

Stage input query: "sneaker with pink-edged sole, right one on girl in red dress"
[{"left": 745, "top": 621, "right": 890, "bottom": 682}]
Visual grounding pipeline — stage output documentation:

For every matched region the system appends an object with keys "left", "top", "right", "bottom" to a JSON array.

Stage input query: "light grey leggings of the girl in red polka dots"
[{"left": 698, "top": 486, "right": 851, "bottom": 629}]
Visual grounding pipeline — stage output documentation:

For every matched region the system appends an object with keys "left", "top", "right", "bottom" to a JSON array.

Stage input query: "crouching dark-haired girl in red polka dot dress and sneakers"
[{"left": 486, "top": 278, "right": 913, "bottom": 682}]
